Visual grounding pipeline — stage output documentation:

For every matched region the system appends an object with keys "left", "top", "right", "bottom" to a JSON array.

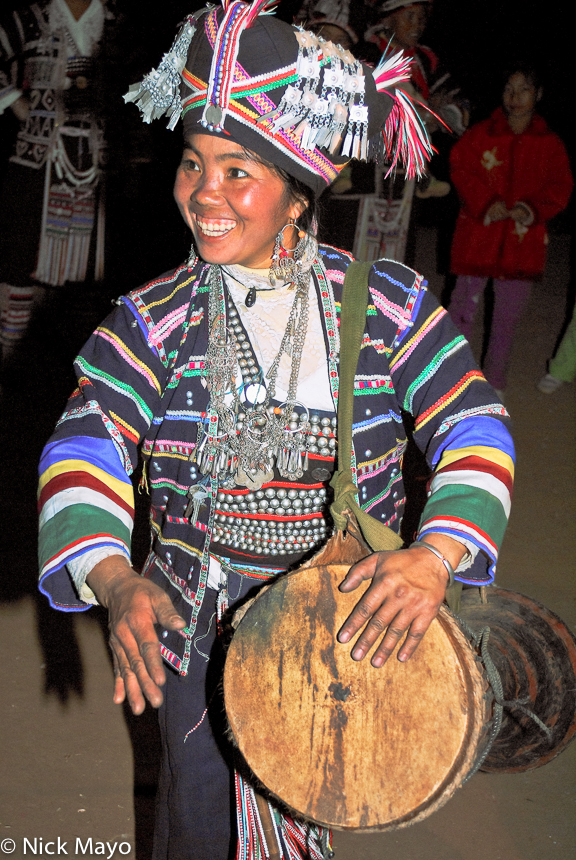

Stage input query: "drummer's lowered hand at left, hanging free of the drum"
[{"left": 86, "top": 555, "right": 186, "bottom": 714}]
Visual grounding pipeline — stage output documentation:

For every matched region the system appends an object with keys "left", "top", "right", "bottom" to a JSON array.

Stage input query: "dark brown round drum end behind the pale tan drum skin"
[{"left": 459, "top": 587, "right": 576, "bottom": 773}]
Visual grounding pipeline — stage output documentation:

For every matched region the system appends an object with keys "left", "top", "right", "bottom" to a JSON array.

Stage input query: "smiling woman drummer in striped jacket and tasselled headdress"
[{"left": 40, "top": 0, "right": 513, "bottom": 860}]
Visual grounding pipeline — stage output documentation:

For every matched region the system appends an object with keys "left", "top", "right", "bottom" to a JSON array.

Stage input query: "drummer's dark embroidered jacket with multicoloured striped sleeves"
[{"left": 39, "top": 246, "right": 513, "bottom": 674}]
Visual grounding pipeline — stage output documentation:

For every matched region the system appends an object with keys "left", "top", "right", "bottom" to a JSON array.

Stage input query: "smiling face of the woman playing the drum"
[{"left": 174, "top": 134, "right": 305, "bottom": 269}]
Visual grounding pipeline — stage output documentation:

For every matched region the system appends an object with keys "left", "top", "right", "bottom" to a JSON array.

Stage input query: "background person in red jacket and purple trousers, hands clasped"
[{"left": 448, "top": 66, "right": 573, "bottom": 392}]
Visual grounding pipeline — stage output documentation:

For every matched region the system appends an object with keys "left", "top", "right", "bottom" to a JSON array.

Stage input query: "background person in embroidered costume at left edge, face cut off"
[{"left": 0, "top": 0, "right": 109, "bottom": 357}]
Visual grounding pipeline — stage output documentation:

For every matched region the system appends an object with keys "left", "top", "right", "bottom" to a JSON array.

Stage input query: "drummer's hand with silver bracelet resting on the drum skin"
[{"left": 338, "top": 535, "right": 466, "bottom": 668}]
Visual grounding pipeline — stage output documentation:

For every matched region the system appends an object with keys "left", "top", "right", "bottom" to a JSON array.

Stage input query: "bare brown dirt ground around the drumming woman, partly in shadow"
[{"left": 0, "top": 225, "right": 576, "bottom": 860}]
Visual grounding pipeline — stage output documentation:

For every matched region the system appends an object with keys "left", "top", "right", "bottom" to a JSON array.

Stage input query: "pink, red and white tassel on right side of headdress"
[{"left": 374, "top": 51, "right": 434, "bottom": 179}]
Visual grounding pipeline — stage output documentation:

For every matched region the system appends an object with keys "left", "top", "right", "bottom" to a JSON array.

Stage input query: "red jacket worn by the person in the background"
[{"left": 450, "top": 108, "right": 573, "bottom": 279}]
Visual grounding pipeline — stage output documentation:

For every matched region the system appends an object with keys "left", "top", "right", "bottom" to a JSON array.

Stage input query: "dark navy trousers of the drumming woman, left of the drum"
[{"left": 153, "top": 574, "right": 261, "bottom": 860}]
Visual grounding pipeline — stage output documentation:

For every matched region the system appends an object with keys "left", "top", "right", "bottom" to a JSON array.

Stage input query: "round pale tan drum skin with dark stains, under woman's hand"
[{"left": 224, "top": 564, "right": 491, "bottom": 831}]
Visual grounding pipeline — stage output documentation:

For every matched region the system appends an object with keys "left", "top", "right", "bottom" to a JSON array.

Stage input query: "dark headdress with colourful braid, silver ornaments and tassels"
[{"left": 124, "top": 0, "right": 432, "bottom": 193}]
